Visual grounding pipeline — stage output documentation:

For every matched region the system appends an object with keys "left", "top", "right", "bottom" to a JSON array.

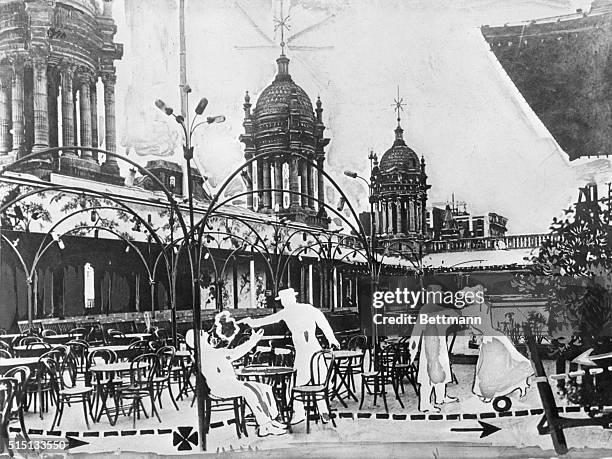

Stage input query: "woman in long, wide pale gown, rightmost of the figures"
[{"left": 462, "top": 285, "right": 534, "bottom": 402}]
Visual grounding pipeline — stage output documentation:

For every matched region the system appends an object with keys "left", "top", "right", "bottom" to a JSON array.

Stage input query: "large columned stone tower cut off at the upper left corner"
[{"left": 0, "top": 0, "right": 123, "bottom": 184}]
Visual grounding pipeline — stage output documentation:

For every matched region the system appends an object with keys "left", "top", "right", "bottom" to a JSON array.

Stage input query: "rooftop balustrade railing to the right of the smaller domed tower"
[{"left": 426, "top": 234, "right": 550, "bottom": 253}]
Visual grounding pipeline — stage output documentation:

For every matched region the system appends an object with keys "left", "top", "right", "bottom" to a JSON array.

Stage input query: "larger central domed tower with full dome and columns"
[{"left": 240, "top": 53, "right": 329, "bottom": 227}]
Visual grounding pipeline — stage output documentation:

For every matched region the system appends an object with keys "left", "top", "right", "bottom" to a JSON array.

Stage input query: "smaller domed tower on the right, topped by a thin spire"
[{"left": 371, "top": 108, "right": 431, "bottom": 240}]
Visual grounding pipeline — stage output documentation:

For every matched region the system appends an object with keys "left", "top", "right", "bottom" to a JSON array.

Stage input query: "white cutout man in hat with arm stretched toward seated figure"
[{"left": 239, "top": 288, "right": 340, "bottom": 424}]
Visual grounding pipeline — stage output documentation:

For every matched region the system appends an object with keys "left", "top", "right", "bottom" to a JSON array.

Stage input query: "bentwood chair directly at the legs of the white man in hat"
[{"left": 289, "top": 350, "right": 336, "bottom": 433}]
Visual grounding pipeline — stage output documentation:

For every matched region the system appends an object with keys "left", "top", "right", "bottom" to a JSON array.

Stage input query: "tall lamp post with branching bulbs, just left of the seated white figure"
[{"left": 155, "top": 97, "right": 225, "bottom": 450}]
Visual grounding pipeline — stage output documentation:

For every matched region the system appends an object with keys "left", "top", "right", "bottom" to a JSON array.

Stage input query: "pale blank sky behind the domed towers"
[{"left": 107, "top": 0, "right": 609, "bottom": 233}]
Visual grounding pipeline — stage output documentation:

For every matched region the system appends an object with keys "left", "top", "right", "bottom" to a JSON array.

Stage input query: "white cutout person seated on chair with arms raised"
[{"left": 185, "top": 311, "right": 286, "bottom": 437}]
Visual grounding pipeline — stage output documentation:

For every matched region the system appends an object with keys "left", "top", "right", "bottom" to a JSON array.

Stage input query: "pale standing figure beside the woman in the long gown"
[{"left": 409, "top": 285, "right": 460, "bottom": 413}]
